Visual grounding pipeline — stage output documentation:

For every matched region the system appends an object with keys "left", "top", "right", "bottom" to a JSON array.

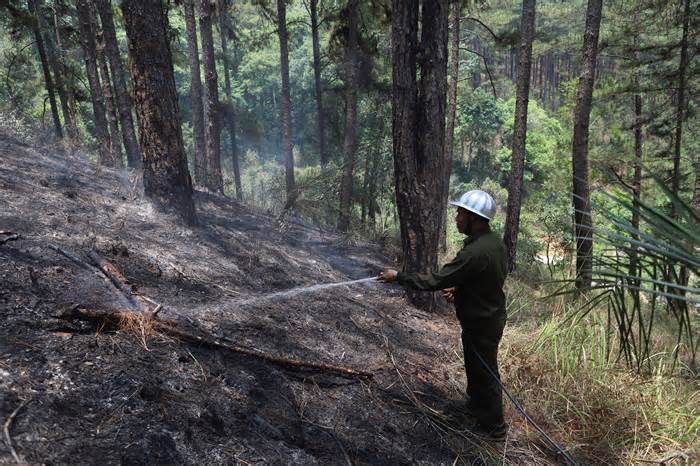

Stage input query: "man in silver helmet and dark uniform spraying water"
[{"left": 379, "top": 190, "right": 507, "bottom": 439}]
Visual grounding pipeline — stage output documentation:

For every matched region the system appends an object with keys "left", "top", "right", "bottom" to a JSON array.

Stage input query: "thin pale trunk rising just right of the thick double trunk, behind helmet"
[{"left": 440, "top": 1, "right": 461, "bottom": 252}]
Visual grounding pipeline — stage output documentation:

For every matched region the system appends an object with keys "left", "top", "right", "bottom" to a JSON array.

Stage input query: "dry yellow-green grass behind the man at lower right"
[{"left": 500, "top": 290, "right": 700, "bottom": 464}]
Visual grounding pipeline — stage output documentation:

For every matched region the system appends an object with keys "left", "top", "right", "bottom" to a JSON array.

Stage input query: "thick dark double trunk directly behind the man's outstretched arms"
[{"left": 392, "top": 0, "right": 448, "bottom": 310}]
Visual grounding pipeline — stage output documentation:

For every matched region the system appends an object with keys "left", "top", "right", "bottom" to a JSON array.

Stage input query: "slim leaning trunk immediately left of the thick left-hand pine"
[{"left": 95, "top": 0, "right": 141, "bottom": 168}]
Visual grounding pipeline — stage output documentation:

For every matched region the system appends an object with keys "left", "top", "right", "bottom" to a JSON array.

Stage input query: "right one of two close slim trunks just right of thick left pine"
[{"left": 199, "top": 0, "right": 224, "bottom": 193}]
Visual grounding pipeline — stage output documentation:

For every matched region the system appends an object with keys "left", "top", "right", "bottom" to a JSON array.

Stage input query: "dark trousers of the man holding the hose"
[{"left": 462, "top": 318, "right": 505, "bottom": 428}]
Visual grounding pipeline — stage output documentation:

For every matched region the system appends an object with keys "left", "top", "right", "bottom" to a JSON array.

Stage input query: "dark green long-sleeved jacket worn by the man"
[{"left": 397, "top": 231, "right": 507, "bottom": 322}]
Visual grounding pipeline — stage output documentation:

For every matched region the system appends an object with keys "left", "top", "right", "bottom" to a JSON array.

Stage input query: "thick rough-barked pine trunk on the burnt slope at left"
[{"left": 121, "top": 0, "right": 196, "bottom": 224}]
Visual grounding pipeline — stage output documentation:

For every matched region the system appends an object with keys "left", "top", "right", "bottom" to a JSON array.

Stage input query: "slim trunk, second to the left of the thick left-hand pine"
[{"left": 75, "top": 0, "right": 115, "bottom": 166}]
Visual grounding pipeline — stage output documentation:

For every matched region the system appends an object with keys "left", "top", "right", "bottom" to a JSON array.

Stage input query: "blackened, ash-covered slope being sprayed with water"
[{"left": 0, "top": 137, "right": 540, "bottom": 464}]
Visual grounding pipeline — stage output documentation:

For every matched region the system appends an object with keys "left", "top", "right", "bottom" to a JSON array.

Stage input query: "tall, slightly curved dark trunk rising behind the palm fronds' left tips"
[{"left": 572, "top": 0, "right": 603, "bottom": 289}]
